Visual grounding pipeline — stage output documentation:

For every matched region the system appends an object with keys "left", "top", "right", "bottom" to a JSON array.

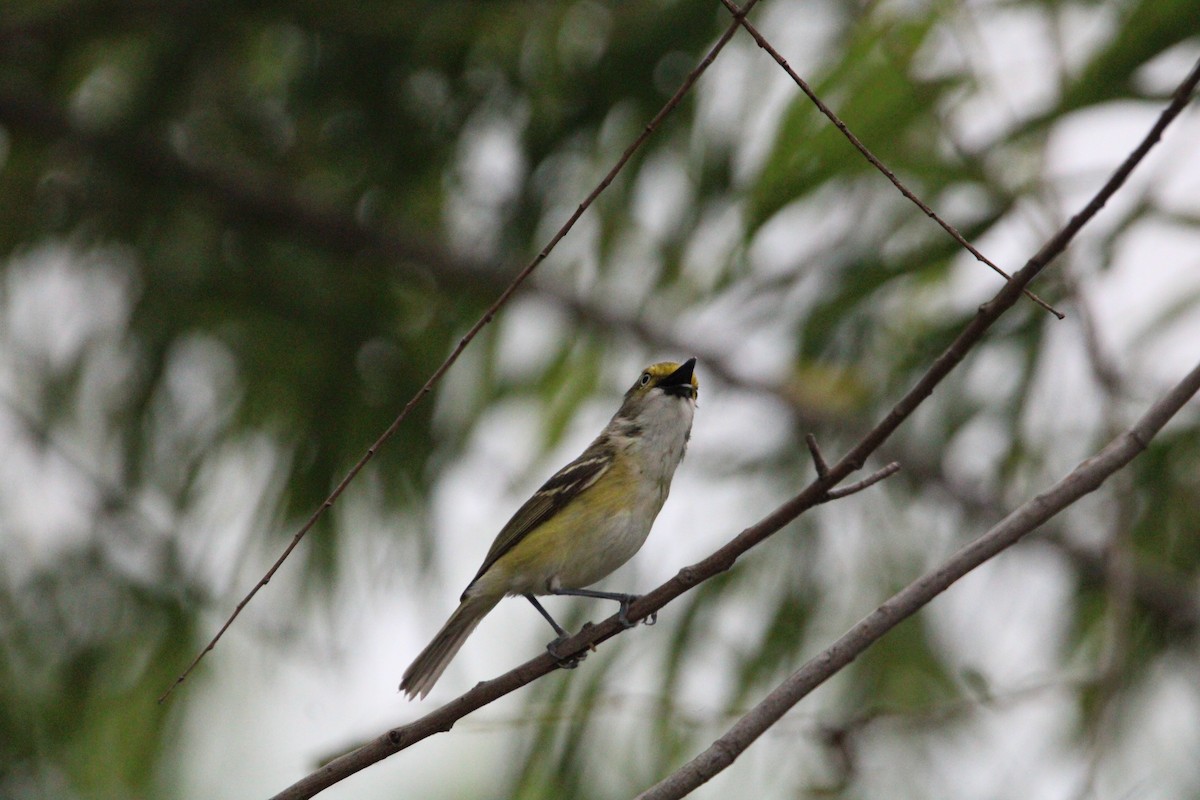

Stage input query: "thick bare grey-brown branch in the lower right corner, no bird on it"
[{"left": 638, "top": 357, "right": 1200, "bottom": 800}]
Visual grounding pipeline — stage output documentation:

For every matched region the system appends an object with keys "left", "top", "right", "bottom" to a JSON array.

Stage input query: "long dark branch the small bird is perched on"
[{"left": 265, "top": 43, "right": 1200, "bottom": 800}]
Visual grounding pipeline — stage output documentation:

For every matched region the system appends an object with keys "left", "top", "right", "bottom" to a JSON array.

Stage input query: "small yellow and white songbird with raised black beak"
[{"left": 400, "top": 357, "right": 700, "bottom": 699}]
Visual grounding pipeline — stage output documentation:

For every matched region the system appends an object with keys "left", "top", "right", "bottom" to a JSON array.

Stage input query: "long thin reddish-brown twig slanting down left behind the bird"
[{"left": 158, "top": 0, "right": 757, "bottom": 703}]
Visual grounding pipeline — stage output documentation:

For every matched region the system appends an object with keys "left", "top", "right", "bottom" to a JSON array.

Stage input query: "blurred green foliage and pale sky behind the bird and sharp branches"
[{"left": 0, "top": 0, "right": 1200, "bottom": 799}]
